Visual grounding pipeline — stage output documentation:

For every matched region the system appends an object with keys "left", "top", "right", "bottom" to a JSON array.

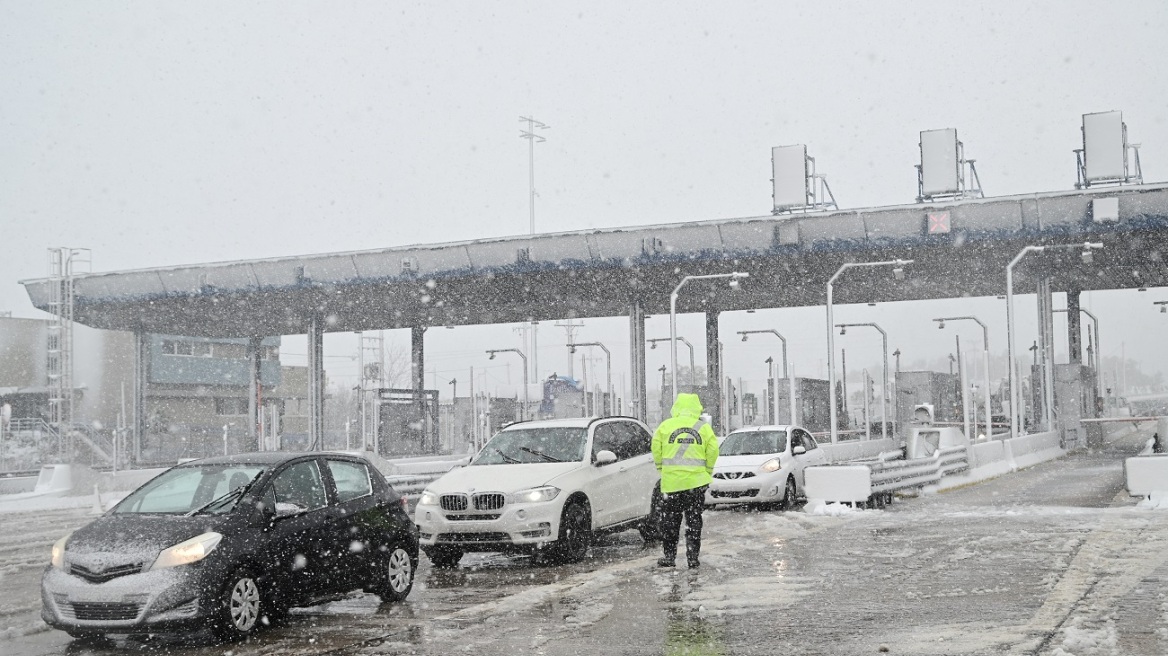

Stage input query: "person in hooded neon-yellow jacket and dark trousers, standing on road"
[{"left": 653, "top": 393, "right": 718, "bottom": 567}]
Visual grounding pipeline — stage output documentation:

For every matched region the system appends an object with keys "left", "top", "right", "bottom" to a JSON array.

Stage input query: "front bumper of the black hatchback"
[{"left": 41, "top": 566, "right": 214, "bottom": 633}]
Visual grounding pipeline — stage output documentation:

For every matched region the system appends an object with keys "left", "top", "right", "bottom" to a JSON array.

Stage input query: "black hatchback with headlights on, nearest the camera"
[{"left": 41, "top": 452, "right": 418, "bottom": 640}]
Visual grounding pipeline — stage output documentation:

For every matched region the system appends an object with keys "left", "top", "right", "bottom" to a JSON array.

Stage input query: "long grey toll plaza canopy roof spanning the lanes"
[{"left": 22, "top": 184, "right": 1168, "bottom": 337}]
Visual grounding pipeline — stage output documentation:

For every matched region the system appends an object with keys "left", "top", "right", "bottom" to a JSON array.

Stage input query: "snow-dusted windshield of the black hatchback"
[{"left": 113, "top": 463, "right": 264, "bottom": 515}]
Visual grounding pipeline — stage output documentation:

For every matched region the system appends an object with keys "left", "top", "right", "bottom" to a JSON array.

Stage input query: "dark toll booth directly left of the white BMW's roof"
[{"left": 377, "top": 389, "right": 440, "bottom": 458}]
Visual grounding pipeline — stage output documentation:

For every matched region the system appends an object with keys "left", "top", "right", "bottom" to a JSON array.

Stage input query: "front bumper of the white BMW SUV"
[{"left": 415, "top": 498, "right": 563, "bottom": 551}]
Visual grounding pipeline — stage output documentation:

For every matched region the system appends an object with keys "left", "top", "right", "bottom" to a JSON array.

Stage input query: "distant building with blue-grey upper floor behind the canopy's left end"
[{"left": 0, "top": 317, "right": 308, "bottom": 461}]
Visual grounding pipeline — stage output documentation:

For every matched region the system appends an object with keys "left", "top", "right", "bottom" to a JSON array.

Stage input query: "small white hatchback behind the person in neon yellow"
[{"left": 705, "top": 426, "right": 827, "bottom": 509}]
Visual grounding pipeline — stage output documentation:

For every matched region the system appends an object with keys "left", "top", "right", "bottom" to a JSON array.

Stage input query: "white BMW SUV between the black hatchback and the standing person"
[{"left": 415, "top": 417, "right": 661, "bottom": 567}]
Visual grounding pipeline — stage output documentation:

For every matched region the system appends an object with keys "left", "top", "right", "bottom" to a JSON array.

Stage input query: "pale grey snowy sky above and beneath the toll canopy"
[{"left": 0, "top": 0, "right": 1168, "bottom": 393}]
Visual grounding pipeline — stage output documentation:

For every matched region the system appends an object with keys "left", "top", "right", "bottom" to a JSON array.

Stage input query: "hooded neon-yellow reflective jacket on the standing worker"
[{"left": 653, "top": 393, "right": 718, "bottom": 494}]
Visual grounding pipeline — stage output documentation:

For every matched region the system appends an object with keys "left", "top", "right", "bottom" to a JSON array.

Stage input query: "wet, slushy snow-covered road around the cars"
[{"left": 0, "top": 432, "right": 1168, "bottom": 656}]
